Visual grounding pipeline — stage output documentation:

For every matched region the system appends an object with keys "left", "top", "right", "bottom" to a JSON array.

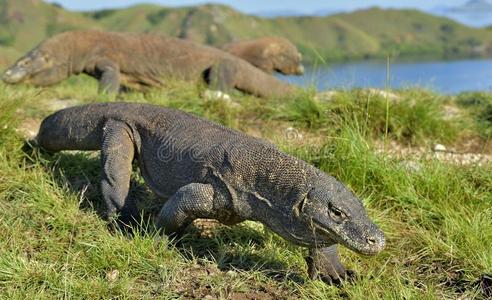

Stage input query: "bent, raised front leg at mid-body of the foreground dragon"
[{"left": 157, "top": 183, "right": 217, "bottom": 235}]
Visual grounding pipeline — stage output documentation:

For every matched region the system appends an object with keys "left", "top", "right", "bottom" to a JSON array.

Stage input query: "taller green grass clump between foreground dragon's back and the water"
[{"left": 273, "top": 90, "right": 464, "bottom": 144}]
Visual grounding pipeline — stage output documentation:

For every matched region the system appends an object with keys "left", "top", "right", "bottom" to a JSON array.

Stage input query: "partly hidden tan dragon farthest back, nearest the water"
[{"left": 220, "top": 37, "right": 304, "bottom": 75}]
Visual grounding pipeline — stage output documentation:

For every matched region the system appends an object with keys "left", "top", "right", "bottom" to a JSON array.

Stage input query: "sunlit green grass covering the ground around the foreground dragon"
[{"left": 0, "top": 77, "right": 492, "bottom": 299}]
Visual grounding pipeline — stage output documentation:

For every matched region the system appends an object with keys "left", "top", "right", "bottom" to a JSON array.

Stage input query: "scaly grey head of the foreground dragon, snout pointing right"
[{"left": 289, "top": 173, "right": 385, "bottom": 255}]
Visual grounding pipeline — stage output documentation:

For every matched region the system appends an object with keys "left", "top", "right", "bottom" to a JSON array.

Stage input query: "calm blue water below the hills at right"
[{"left": 279, "top": 59, "right": 492, "bottom": 94}]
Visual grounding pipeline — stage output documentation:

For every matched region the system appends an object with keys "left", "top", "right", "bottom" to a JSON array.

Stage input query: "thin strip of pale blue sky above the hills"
[{"left": 48, "top": 0, "right": 466, "bottom": 13}]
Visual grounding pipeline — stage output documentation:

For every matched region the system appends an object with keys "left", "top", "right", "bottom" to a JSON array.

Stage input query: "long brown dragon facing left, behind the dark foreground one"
[{"left": 2, "top": 31, "right": 295, "bottom": 97}]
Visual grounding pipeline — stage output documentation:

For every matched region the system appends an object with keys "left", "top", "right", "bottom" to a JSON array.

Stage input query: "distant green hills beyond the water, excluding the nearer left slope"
[{"left": 84, "top": 5, "right": 492, "bottom": 60}]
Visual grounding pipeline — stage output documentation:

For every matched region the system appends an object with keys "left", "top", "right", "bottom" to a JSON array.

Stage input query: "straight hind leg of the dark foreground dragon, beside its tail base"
[{"left": 101, "top": 120, "right": 137, "bottom": 226}]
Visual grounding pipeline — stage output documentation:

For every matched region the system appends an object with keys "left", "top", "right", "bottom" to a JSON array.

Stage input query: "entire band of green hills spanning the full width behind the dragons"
[{"left": 0, "top": 0, "right": 492, "bottom": 61}]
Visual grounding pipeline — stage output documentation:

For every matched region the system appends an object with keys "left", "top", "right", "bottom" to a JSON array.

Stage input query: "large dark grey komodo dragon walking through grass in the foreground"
[{"left": 35, "top": 103, "right": 385, "bottom": 282}]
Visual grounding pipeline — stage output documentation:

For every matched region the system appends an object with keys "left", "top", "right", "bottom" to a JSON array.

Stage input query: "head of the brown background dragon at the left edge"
[{"left": 2, "top": 47, "right": 67, "bottom": 86}]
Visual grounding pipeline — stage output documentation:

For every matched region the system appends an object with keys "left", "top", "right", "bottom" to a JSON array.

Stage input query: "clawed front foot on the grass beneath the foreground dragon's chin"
[{"left": 306, "top": 244, "right": 355, "bottom": 285}]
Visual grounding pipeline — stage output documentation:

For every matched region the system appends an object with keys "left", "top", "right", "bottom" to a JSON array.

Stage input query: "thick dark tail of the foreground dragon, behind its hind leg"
[{"left": 35, "top": 105, "right": 107, "bottom": 152}]
